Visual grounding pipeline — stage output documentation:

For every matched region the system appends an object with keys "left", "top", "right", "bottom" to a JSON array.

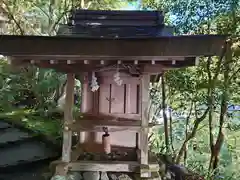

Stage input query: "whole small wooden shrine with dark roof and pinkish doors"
[{"left": 0, "top": 10, "right": 226, "bottom": 177}]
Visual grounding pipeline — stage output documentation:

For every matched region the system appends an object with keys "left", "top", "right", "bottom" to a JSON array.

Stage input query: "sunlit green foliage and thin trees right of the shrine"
[{"left": 143, "top": 0, "right": 240, "bottom": 179}]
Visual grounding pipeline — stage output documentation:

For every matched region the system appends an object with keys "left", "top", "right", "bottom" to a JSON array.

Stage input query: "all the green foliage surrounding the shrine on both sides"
[{"left": 0, "top": 0, "right": 240, "bottom": 180}]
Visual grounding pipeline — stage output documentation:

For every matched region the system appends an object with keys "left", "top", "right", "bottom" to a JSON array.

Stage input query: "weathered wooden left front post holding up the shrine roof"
[{"left": 62, "top": 73, "right": 75, "bottom": 163}]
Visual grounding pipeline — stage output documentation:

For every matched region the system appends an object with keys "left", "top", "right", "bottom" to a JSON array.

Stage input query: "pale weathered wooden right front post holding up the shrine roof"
[{"left": 139, "top": 74, "right": 151, "bottom": 177}]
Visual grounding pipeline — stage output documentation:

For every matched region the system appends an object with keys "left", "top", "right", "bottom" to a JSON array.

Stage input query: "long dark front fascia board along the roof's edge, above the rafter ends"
[{"left": 0, "top": 35, "right": 227, "bottom": 57}]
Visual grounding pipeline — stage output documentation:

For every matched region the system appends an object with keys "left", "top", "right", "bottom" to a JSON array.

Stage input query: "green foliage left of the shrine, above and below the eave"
[{"left": 0, "top": 0, "right": 133, "bottom": 141}]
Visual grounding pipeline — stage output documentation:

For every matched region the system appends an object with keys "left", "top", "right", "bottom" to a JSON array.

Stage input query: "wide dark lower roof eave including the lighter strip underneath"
[{"left": 0, "top": 35, "right": 227, "bottom": 71}]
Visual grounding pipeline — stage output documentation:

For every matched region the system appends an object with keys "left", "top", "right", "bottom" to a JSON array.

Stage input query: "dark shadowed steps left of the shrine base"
[{"left": 0, "top": 120, "right": 59, "bottom": 180}]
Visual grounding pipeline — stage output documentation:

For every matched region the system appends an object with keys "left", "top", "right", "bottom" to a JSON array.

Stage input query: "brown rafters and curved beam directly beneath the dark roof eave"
[{"left": 8, "top": 57, "right": 195, "bottom": 74}]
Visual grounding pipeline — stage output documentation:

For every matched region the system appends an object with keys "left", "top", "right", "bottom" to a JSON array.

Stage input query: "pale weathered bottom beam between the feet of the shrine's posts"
[{"left": 69, "top": 161, "right": 140, "bottom": 172}]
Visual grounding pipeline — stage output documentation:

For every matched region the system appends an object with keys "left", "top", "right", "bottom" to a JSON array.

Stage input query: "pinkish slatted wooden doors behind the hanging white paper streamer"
[{"left": 99, "top": 72, "right": 140, "bottom": 118}]
